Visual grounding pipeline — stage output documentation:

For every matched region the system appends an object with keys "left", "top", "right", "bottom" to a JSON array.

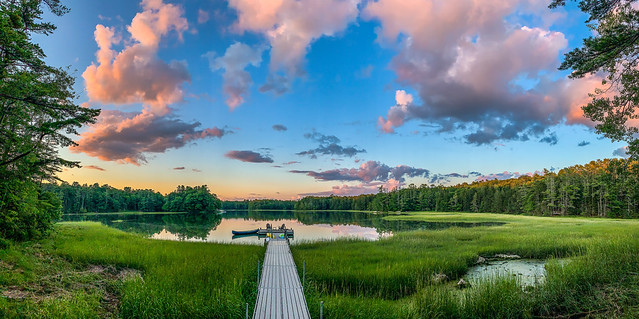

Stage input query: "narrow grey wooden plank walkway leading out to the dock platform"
[{"left": 253, "top": 239, "right": 311, "bottom": 319}]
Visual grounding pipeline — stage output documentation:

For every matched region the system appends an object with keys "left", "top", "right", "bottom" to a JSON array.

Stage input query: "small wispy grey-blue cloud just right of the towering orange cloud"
[{"left": 205, "top": 42, "right": 264, "bottom": 110}]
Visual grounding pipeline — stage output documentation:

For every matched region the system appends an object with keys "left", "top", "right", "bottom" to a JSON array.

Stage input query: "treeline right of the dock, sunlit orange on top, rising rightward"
[{"left": 295, "top": 159, "right": 639, "bottom": 218}]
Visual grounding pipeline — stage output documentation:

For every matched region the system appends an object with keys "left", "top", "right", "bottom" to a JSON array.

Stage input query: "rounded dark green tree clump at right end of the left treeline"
[{"left": 162, "top": 185, "right": 222, "bottom": 212}]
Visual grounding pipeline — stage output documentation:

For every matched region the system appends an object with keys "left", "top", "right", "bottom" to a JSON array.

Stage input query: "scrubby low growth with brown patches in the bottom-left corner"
[{"left": 0, "top": 240, "right": 115, "bottom": 318}]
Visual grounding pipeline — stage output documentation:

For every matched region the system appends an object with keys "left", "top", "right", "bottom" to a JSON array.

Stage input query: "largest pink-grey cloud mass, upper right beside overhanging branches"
[{"left": 362, "top": 0, "right": 601, "bottom": 145}]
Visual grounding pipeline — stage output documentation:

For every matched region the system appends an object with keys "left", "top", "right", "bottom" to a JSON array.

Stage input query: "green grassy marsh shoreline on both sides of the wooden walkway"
[{"left": 0, "top": 212, "right": 639, "bottom": 318}]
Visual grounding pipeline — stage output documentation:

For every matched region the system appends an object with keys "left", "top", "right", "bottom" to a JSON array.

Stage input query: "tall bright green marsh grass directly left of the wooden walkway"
[{"left": 55, "top": 222, "right": 264, "bottom": 318}]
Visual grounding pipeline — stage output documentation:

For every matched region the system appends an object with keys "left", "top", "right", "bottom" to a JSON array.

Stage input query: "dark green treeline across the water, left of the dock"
[{"left": 42, "top": 183, "right": 221, "bottom": 214}]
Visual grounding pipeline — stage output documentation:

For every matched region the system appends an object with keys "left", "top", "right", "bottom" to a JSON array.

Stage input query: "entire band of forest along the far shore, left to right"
[{"left": 43, "top": 159, "right": 639, "bottom": 218}]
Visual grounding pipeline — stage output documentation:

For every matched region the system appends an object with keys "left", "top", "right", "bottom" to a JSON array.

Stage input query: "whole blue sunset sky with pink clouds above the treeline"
[{"left": 34, "top": 0, "right": 625, "bottom": 200}]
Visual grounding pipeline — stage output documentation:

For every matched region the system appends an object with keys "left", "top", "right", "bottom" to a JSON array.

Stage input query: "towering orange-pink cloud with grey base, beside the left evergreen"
[{"left": 76, "top": 0, "right": 230, "bottom": 165}]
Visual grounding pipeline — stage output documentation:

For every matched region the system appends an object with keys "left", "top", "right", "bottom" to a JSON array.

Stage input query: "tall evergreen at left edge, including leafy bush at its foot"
[{"left": 0, "top": 0, "right": 100, "bottom": 240}]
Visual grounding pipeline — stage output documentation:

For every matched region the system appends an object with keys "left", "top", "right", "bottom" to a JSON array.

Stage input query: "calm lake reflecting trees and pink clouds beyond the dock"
[{"left": 62, "top": 211, "right": 503, "bottom": 244}]
